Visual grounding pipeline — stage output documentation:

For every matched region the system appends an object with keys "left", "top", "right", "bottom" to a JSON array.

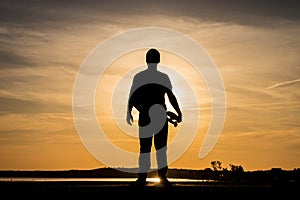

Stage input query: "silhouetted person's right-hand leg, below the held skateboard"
[{"left": 154, "top": 121, "right": 168, "bottom": 179}]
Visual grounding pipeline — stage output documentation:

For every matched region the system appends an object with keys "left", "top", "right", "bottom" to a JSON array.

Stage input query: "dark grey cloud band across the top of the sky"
[{"left": 0, "top": 0, "right": 300, "bottom": 27}]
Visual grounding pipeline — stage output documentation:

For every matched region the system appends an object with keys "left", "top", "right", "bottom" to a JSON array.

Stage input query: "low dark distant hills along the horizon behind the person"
[{"left": 0, "top": 168, "right": 300, "bottom": 185}]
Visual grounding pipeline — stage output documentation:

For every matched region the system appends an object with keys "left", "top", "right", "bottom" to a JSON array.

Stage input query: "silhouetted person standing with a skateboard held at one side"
[{"left": 126, "top": 49, "right": 182, "bottom": 185}]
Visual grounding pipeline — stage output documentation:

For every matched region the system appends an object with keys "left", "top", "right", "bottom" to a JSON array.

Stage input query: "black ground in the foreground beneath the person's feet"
[{"left": 0, "top": 181, "right": 300, "bottom": 199}]
